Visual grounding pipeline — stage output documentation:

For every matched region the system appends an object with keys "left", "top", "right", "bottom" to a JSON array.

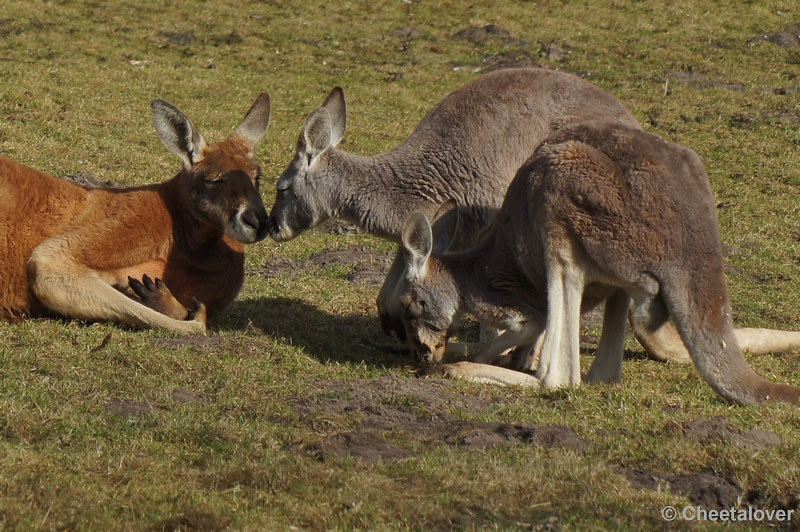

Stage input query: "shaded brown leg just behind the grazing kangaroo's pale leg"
[{"left": 584, "top": 290, "right": 631, "bottom": 383}]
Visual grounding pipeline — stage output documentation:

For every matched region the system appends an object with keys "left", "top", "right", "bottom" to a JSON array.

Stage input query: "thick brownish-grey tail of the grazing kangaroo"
[{"left": 661, "top": 268, "right": 800, "bottom": 404}]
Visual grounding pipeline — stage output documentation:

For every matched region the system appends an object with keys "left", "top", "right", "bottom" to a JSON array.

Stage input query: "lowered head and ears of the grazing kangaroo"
[{"left": 394, "top": 200, "right": 460, "bottom": 364}]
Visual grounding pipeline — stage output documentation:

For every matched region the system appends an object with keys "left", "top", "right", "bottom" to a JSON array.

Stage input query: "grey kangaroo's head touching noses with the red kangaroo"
[{"left": 269, "top": 87, "right": 347, "bottom": 242}]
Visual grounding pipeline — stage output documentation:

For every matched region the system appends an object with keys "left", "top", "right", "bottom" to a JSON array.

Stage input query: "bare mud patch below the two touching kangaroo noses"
[{"left": 245, "top": 246, "right": 394, "bottom": 285}]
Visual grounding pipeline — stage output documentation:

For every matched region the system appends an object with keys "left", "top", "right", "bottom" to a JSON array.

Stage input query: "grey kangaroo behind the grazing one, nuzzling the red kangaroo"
[{"left": 269, "top": 68, "right": 800, "bottom": 363}]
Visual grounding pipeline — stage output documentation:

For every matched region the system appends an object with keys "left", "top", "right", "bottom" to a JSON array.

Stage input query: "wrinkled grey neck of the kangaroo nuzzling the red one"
[{"left": 328, "top": 147, "right": 446, "bottom": 243}]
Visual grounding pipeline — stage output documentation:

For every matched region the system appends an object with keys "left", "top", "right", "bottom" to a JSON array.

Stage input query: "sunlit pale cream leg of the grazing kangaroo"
[{"left": 536, "top": 257, "right": 584, "bottom": 388}]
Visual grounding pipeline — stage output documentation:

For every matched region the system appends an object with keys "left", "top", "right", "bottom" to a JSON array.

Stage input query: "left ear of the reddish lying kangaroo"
[{"left": 150, "top": 100, "right": 206, "bottom": 170}]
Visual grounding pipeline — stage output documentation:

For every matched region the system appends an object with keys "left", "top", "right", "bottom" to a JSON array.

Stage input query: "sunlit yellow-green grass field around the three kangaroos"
[{"left": 0, "top": 0, "right": 800, "bottom": 530}]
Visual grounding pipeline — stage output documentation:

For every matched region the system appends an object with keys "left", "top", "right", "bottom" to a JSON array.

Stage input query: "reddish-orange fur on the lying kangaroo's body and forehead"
[{"left": 0, "top": 150, "right": 248, "bottom": 320}]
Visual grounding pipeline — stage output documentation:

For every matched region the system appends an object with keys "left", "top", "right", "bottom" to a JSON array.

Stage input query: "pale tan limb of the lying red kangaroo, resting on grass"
[{"left": 28, "top": 254, "right": 206, "bottom": 334}]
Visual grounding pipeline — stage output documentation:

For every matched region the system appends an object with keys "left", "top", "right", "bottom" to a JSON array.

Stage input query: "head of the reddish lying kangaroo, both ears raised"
[{"left": 152, "top": 92, "right": 270, "bottom": 244}]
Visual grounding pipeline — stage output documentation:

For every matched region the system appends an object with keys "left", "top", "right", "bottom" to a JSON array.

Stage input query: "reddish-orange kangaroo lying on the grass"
[{"left": 0, "top": 93, "right": 270, "bottom": 334}]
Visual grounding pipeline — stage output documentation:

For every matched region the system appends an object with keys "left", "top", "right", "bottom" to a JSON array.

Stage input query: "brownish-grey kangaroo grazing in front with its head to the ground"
[{"left": 400, "top": 121, "right": 800, "bottom": 403}]
